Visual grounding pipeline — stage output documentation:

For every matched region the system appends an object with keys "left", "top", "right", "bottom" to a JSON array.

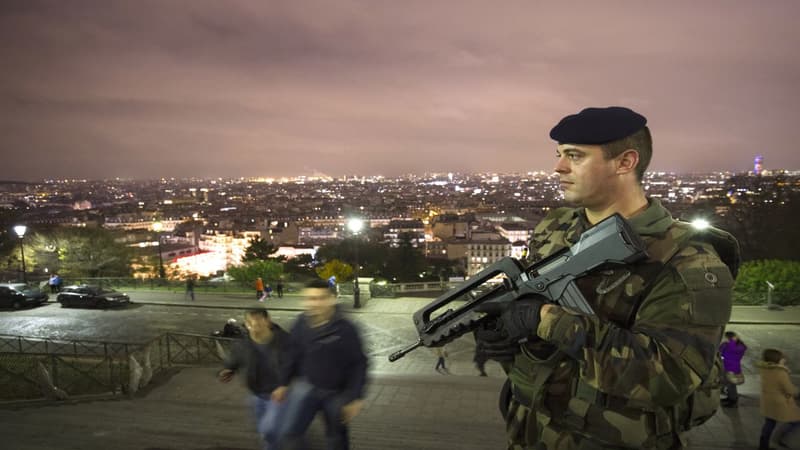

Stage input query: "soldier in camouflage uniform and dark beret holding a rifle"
[{"left": 476, "top": 107, "right": 739, "bottom": 450}]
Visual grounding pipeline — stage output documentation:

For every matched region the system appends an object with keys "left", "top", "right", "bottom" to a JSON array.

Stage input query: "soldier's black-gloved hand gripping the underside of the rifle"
[{"left": 475, "top": 298, "right": 545, "bottom": 361}]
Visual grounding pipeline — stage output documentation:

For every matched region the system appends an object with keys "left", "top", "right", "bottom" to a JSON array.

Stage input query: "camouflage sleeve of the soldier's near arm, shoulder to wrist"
[{"left": 537, "top": 244, "right": 733, "bottom": 406}]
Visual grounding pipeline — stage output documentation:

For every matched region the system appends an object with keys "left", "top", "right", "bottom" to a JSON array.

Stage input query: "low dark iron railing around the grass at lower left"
[{"left": 0, "top": 332, "right": 236, "bottom": 400}]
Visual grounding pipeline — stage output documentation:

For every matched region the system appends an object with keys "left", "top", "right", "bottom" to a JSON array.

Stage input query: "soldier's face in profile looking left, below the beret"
[{"left": 555, "top": 144, "right": 616, "bottom": 208}]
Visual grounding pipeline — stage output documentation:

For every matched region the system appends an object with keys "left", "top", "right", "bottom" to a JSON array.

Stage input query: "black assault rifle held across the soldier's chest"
[{"left": 389, "top": 214, "right": 647, "bottom": 361}]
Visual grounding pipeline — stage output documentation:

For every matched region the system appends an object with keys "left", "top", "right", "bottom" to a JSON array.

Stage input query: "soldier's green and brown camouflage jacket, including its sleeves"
[{"left": 506, "top": 199, "right": 735, "bottom": 449}]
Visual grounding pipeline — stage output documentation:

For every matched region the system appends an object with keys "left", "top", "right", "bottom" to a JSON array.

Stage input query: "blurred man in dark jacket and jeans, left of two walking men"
[{"left": 218, "top": 309, "right": 288, "bottom": 449}]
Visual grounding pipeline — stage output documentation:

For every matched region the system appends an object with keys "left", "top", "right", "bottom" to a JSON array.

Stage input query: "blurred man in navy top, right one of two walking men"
[{"left": 272, "top": 279, "right": 367, "bottom": 450}]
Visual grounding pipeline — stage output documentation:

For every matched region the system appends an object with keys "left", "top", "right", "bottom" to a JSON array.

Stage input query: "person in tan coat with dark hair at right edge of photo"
[{"left": 756, "top": 348, "right": 800, "bottom": 450}]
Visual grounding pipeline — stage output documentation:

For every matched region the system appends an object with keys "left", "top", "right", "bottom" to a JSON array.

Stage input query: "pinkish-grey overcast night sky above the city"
[{"left": 0, "top": 0, "right": 800, "bottom": 180}]
